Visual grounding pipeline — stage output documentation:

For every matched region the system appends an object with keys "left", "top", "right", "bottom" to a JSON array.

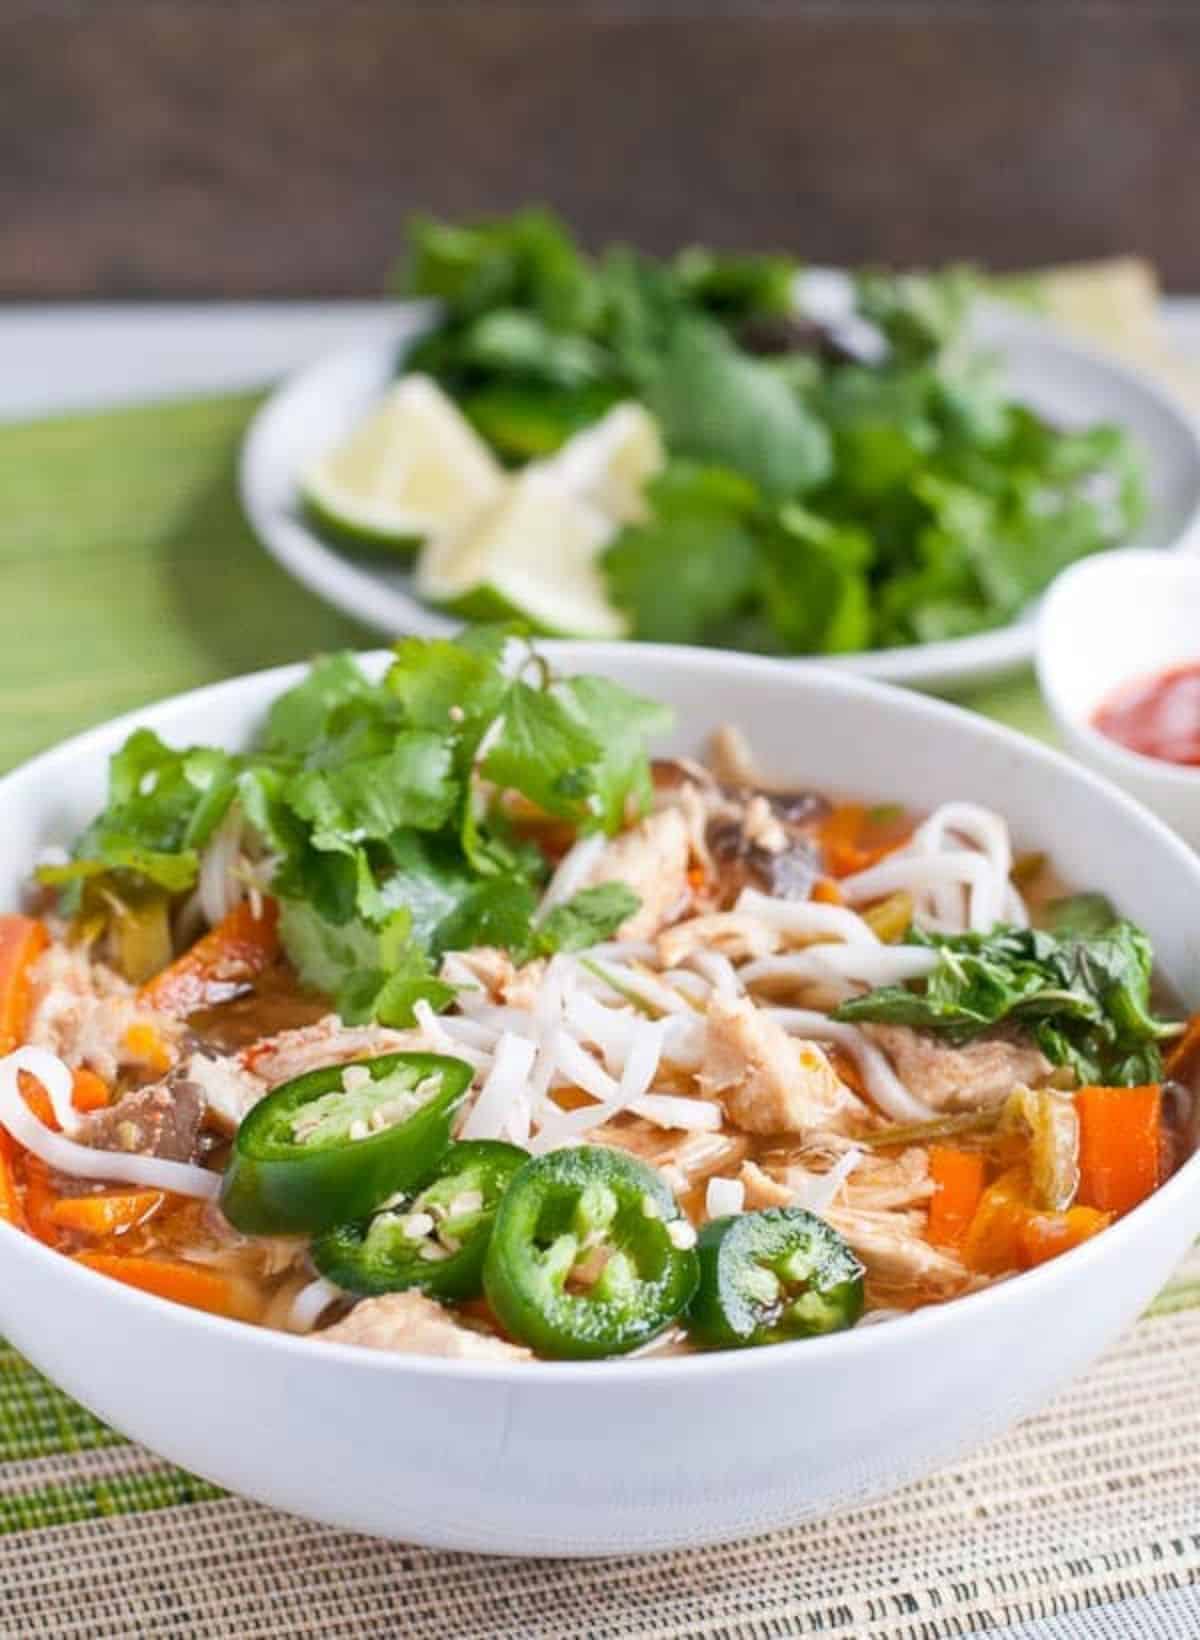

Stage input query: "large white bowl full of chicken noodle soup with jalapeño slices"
[{"left": 0, "top": 636, "right": 1200, "bottom": 1555}]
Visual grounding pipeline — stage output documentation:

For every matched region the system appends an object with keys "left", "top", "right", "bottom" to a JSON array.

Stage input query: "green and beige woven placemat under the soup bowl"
[{"left": 0, "top": 395, "right": 1200, "bottom": 1640}]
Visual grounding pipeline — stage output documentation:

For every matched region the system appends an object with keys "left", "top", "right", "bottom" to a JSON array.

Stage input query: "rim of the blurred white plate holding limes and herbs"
[{"left": 239, "top": 302, "right": 1200, "bottom": 687}]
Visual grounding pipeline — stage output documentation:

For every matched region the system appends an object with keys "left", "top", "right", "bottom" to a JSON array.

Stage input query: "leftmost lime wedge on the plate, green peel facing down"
[{"left": 300, "top": 376, "right": 505, "bottom": 548}]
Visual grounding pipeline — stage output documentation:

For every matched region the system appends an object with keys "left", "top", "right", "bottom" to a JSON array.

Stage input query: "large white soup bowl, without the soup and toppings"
[{"left": 0, "top": 645, "right": 1200, "bottom": 1555}]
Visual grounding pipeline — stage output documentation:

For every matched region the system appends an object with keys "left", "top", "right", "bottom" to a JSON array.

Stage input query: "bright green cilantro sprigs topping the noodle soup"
[{"left": 41, "top": 628, "right": 670, "bottom": 1025}]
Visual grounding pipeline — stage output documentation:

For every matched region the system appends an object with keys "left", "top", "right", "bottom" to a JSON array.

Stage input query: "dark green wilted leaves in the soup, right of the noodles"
[{"left": 834, "top": 924, "right": 1174, "bottom": 1086}]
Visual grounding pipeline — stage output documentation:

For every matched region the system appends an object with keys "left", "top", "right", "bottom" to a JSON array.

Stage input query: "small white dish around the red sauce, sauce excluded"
[{"left": 1036, "top": 551, "right": 1200, "bottom": 848}]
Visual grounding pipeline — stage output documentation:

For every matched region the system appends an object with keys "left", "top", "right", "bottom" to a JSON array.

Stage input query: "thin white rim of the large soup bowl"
[{"left": 9, "top": 640, "right": 1200, "bottom": 1387}]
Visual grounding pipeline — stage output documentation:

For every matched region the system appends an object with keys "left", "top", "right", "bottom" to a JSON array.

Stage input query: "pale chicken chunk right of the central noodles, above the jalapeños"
[{"left": 700, "top": 992, "right": 867, "bottom": 1133}]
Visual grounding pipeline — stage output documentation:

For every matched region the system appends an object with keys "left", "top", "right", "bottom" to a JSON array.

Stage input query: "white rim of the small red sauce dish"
[{"left": 1034, "top": 546, "right": 1200, "bottom": 794}]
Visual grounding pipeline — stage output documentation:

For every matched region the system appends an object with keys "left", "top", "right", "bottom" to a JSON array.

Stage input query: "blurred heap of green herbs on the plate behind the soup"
[{"left": 391, "top": 210, "right": 1144, "bottom": 654}]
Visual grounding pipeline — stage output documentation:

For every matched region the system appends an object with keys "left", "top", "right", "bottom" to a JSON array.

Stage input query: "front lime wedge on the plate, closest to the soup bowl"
[{"left": 416, "top": 467, "right": 625, "bottom": 638}]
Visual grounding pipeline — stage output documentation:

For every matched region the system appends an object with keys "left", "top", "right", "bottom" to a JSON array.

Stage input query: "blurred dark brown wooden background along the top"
[{"left": 0, "top": 0, "right": 1200, "bottom": 298}]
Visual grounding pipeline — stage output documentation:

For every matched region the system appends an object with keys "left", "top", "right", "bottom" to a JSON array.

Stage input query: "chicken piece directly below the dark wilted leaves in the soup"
[{"left": 862, "top": 1025, "right": 1052, "bottom": 1110}]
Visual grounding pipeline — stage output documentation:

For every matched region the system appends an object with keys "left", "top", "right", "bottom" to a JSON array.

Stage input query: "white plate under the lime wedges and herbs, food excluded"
[{"left": 241, "top": 303, "right": 1200, "bottom": 686}]
